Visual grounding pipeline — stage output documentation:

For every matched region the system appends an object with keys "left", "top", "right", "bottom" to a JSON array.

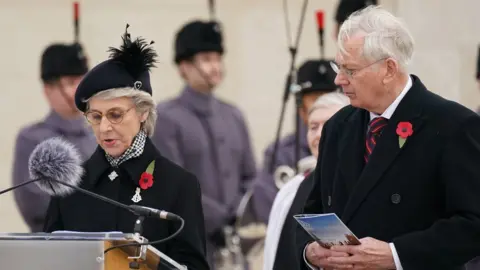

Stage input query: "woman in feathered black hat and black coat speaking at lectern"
[{"left": 44, "top": 25, "right": 209, "bottom": 269}]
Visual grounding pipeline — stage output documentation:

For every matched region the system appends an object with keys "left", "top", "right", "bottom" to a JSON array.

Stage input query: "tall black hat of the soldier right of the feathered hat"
[{"left": 175, "top": 20, "right": 224, "bottom": 64}]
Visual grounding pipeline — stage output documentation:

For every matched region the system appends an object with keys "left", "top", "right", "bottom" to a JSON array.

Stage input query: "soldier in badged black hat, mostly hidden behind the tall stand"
[{"left": 252, "top": 60, "right": 337, "bottom": 223}]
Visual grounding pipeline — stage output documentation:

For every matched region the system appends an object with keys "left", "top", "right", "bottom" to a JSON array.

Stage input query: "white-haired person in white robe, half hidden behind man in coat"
[{"left": 263, "top": 92, "right": 349, "bottom": 270}]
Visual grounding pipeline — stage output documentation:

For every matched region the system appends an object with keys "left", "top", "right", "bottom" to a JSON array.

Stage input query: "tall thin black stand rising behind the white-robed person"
[{"left": 269, "top": 0, "right": 308, "bottom": 173}]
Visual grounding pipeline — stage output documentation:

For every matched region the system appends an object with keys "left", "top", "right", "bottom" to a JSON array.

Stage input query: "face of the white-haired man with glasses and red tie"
[{"left": 335, "top": 36, "right": 386, "bottom": 111}]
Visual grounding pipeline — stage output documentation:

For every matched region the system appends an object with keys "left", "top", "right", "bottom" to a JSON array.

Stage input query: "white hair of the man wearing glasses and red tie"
[{"left": 337, "top": 5, "right": 414, "bottom": 71}]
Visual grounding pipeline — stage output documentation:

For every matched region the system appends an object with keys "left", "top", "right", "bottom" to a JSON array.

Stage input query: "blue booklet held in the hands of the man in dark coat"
[{"left": 293, "top": 213, "right": 360, "bottom": 248}]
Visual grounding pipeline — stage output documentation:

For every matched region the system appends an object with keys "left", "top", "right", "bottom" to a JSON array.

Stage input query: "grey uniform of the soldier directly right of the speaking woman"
[{"left": 153, "top": 87, "right": 256, "bottom": 266}]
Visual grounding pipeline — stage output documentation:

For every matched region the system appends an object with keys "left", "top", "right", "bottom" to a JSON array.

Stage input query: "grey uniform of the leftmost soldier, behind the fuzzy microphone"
[{"left": 12, "top": 111, "right": 97, "bottom": 232}]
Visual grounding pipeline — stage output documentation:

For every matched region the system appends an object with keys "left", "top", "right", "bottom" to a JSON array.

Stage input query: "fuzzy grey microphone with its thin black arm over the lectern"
[{"left": 25, "top": 137, "right": 182, "bottom": 223}]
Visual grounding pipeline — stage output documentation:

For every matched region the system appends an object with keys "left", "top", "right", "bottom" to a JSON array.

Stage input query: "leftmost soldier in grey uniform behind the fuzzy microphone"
[{"left": 12, "top": 43, "right": 96, "bottom": 232}]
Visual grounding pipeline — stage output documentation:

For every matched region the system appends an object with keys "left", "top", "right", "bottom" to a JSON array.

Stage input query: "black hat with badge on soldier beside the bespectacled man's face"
[{"left": 297, "top": 60, "right": 337, "bottom": 95}]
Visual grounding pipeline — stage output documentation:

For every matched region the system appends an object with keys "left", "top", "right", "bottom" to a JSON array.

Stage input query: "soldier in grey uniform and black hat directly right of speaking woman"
[{"left": 153, "top": 21, "right": 256, "bottom": 268}]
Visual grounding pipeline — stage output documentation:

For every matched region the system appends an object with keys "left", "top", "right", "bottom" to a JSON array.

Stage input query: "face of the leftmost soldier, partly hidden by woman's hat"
[{"left": 45, "top": 76, "right": 83, "bottom": 119}]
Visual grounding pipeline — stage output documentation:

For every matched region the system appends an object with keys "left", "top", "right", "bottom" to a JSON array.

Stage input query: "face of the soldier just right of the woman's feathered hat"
[{"left": 180, "top": 52, "right": 223, "bottom": 91}]
